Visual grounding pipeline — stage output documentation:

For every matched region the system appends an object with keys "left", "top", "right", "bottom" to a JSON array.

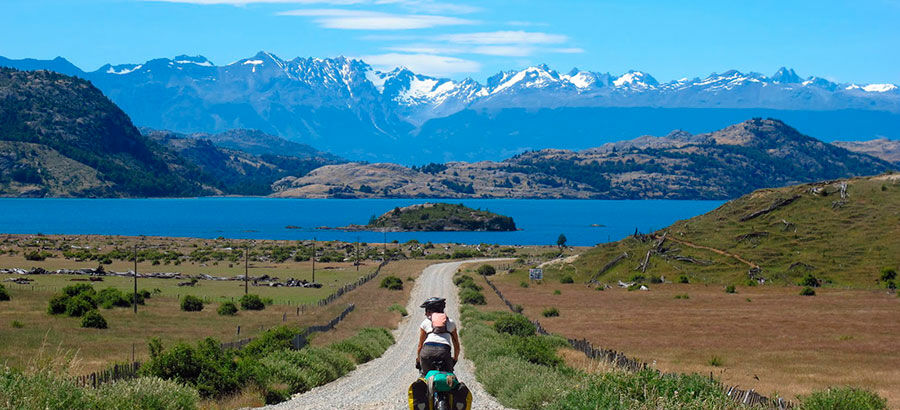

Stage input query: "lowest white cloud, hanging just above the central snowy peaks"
[{"left": 359, "top": 53, "right": 481, "bottom": 77}]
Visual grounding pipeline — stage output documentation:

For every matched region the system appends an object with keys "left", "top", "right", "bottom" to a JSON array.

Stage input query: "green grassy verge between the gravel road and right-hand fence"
[{"left": 461, "top": 306, "right": 737, "bottom": 409}]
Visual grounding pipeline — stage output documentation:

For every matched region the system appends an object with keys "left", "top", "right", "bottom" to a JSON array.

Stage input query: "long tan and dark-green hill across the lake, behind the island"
[{"left": 274, "top": 118, "right": 897, "bottom": 199}]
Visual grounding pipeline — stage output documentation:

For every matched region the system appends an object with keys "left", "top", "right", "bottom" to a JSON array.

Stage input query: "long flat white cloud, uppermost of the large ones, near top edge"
[{"left": 278, "top": 9, "right": 475, "bottom": 30}]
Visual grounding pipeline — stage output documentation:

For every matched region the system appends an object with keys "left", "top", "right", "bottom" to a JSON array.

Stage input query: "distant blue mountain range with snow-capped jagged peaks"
[{"left": 0, "top": 52, "right": 900, "bottom": 160}]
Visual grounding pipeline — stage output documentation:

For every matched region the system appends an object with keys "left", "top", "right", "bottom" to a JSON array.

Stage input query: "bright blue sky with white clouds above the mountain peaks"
[{"left": 0, "top": 0, "right": 900, "bottom": 83}]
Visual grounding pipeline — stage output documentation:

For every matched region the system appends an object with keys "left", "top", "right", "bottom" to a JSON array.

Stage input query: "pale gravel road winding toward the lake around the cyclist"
[{"left": 266, "top": 261, "right": 505, "bottom": 410}]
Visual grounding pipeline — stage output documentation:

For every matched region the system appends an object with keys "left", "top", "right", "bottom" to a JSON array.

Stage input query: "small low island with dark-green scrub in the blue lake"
[{"left": 336, "top": 203, "right": 516, "bottom": 232}]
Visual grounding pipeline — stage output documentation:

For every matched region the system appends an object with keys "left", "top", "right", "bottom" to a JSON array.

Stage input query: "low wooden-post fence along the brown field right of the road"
[{"left": 482, "top": 276, "right": 794, "bottom": 410}]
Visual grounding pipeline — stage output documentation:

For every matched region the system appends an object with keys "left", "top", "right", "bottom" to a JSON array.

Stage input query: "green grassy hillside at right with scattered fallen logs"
[{"left": 560, "top": 173, "right": 900, "bottom": 288}]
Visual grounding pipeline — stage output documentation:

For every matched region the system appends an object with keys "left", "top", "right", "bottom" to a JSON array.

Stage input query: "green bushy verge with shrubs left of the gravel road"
[{"left": 0, "top": 327, "right": 394, "bottom": 410}]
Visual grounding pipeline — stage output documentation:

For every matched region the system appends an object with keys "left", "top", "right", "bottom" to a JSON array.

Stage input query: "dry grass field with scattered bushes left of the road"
[{"left": 0, "top": 261, "right": 433, "bottom": 375}]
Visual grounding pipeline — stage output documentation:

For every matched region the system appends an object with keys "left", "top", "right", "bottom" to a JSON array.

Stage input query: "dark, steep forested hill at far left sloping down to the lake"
[{"left": 0, "top": 68, "right": 218, "bottom": 197}]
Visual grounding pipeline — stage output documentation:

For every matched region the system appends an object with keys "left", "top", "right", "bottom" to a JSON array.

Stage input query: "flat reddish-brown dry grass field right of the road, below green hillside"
[{"left": 486, "top": 274, "right": 900, "bottom": 408}]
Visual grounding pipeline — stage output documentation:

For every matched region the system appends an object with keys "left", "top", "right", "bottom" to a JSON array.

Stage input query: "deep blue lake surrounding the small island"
[{"left": 0, "top": 198, "right": 724, "bottom": 246}]
